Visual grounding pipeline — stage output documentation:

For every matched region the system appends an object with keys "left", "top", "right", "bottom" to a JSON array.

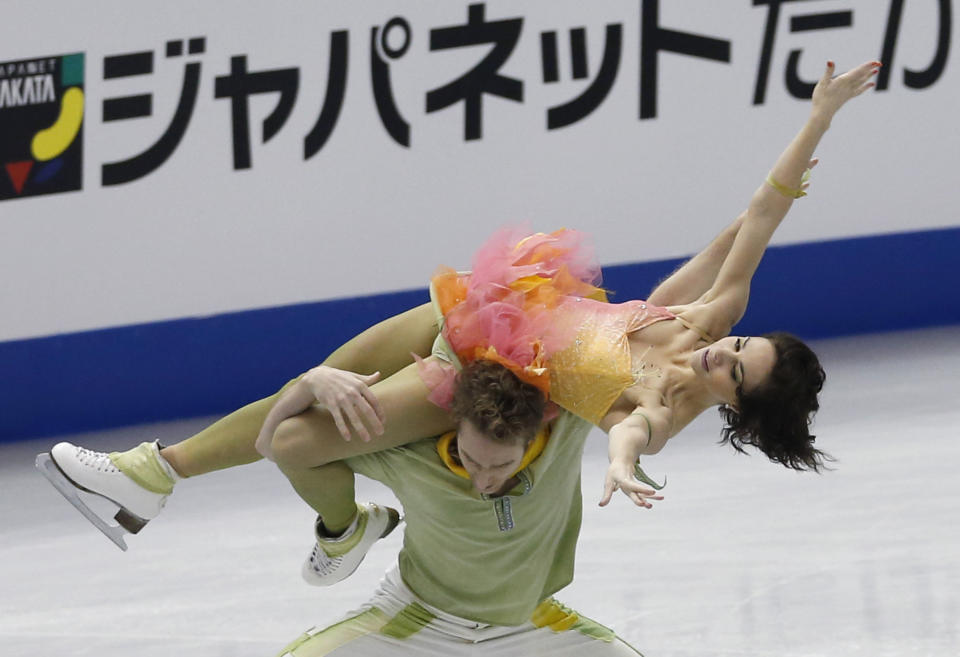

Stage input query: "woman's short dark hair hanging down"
[{"left": 720, "top": 333, "right": 834, "bottom": 472}]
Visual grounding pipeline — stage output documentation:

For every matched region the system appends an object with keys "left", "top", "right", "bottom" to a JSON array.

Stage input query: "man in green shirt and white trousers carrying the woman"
[{"left": 272, "top": 360, "right": 644, "bottom": 657}]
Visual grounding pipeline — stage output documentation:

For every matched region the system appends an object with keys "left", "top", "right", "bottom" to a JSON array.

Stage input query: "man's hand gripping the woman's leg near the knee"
[{"left": 303, "top": 365, "right": 384, "bottom": 441}]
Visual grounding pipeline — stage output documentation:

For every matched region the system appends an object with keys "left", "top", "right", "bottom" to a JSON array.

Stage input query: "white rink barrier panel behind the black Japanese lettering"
[{"left": 0, "top": 0, "right": 960, "bottom": 340}]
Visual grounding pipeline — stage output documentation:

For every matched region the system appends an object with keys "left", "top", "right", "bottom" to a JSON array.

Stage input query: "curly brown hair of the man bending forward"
[{"left": 451, "top": 360, "right": 546, "bottom": 442}]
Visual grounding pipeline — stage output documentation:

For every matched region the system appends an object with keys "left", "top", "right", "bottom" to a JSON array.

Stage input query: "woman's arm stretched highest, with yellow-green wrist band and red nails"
[{"left": 687, "top": 61, "right": 880, "bottom": 335}]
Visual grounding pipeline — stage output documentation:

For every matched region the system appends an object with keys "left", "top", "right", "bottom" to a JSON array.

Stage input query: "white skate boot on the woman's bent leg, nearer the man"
[{"left": 301, "top": 503, "right": 402, "bottom": 586}]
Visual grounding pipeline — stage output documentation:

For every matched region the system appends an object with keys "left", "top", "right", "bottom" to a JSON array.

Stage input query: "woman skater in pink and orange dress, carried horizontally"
[{"left": 38, "top": 61, "right": 880, "bottom": 558}]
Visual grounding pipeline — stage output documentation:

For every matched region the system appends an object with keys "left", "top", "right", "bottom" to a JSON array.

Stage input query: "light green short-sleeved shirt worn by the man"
[{"left": 347, "top": 411, "right": 592, "bottom": 625}]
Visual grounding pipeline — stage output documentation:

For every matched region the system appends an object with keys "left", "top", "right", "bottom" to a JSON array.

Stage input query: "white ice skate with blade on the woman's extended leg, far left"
[{"left": 36, "top": 443, "right": 167, "bottom": 551}]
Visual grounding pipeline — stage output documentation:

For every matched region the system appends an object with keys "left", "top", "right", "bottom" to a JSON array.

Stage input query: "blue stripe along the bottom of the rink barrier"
[{"left": 0, "top": 228, "right": 960, "bottom": 442}]
